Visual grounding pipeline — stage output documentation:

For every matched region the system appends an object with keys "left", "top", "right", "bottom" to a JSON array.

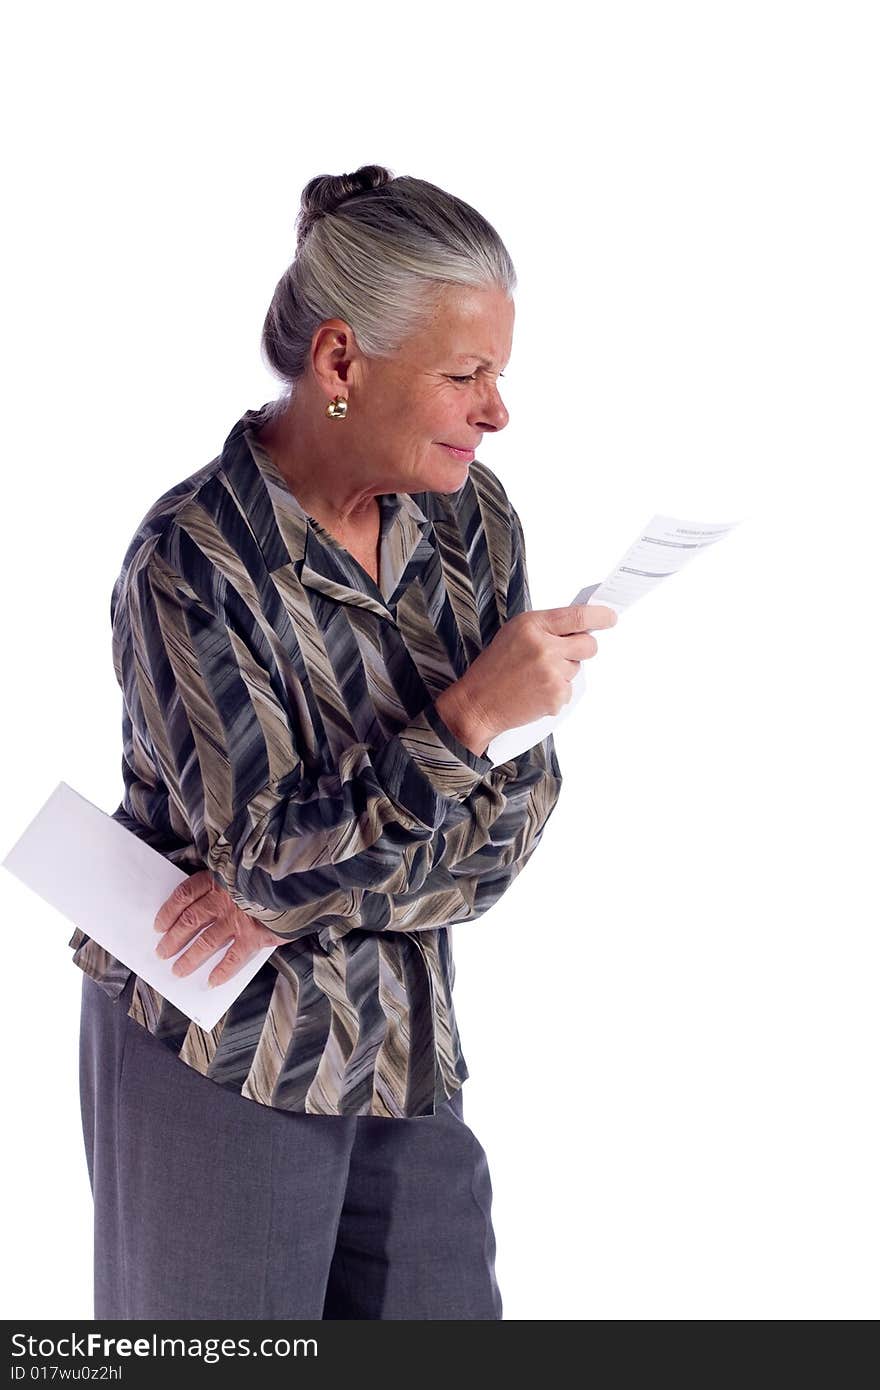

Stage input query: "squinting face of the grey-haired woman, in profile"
[{"left": 343, "top": 285, "right": 514, "bottom": 492}]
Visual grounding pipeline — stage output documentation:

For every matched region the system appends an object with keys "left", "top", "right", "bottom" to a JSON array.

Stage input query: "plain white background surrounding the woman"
[{"left": 0, "top": 0, "right": 880, "bottom": 1319}]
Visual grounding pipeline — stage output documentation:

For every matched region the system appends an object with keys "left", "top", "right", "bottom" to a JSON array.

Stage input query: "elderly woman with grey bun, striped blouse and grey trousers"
[{"left": 71, "top": 165, "right": 614, "bottom": 1319}]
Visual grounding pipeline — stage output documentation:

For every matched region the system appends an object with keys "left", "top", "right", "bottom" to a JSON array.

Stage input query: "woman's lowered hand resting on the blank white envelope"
[{"left": 153, "top": 869, "right": 288, "bottom": 984}]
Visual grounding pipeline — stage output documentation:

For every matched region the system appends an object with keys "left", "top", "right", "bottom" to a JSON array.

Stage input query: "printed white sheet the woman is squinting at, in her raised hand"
[{"left": 487, "top": 516, "right": 740, "bottom": 765}]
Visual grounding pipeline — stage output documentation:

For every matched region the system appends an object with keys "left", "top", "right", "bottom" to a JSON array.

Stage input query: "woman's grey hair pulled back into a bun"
[{"left": 261, "top": 164, "right": 516, "bottom": 410}]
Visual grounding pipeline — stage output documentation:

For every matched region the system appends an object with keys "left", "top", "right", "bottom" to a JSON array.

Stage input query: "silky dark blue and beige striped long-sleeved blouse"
[{"left": 70, "top": 406, "right": 562, "bottom": 1118}]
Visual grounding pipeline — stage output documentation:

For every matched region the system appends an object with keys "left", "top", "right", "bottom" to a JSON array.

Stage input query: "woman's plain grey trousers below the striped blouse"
[{"left": 79, "top": 974, "right": 502, "bottom": 1319}]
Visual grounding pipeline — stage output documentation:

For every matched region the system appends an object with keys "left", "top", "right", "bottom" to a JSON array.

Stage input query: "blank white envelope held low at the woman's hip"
[{"left": 3, "top": 783, "right": 278, "bottom": 1029}]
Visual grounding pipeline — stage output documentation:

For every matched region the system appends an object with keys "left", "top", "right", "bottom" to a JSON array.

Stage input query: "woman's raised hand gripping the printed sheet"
[{"left": 435, "top": 603, "right": 617, "bottom": 752}]
